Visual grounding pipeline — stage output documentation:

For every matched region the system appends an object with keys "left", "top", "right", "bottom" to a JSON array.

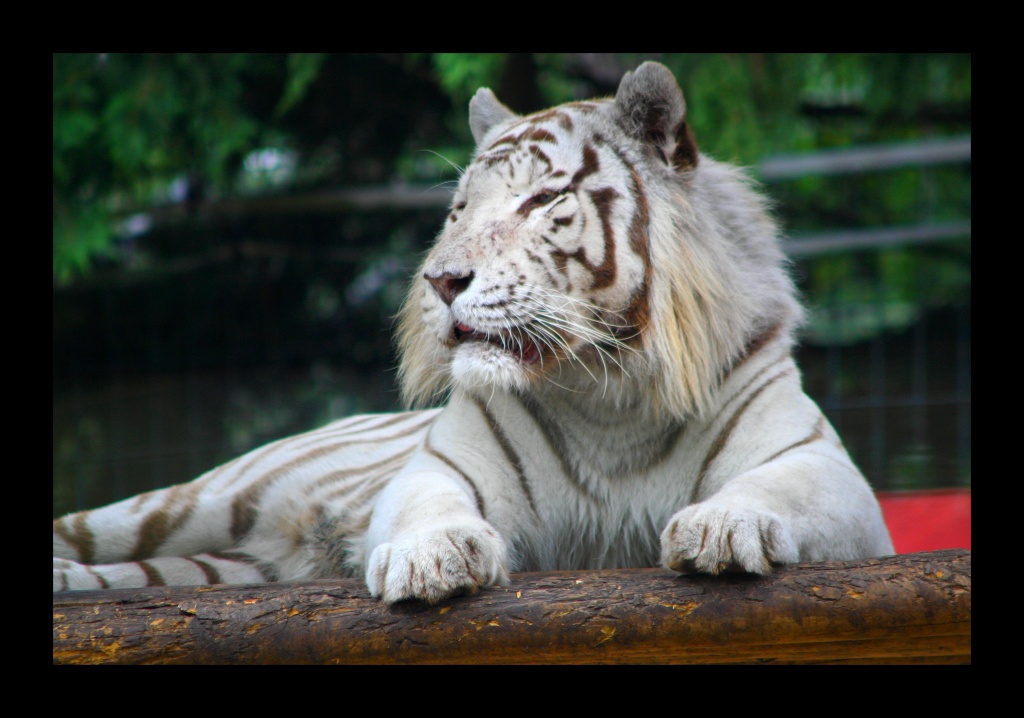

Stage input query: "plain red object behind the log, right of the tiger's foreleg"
[{"left": 878, "top": 489, "right": 971, "bottom": 553}]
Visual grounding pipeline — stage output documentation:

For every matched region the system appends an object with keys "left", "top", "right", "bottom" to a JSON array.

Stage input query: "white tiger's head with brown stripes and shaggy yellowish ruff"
[{"left": 398, "top": 62, "right": 800, "bottom": 419}]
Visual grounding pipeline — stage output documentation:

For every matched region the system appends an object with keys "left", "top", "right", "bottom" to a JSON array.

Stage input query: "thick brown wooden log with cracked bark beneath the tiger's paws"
[{"left": 53, "top": 549, "right": 971, "bottom": 664}]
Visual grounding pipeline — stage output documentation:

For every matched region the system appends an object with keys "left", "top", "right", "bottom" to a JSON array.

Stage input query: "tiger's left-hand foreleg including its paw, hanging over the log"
[{"left": 367, "top": 472, "right": 509, "bottom": 603}]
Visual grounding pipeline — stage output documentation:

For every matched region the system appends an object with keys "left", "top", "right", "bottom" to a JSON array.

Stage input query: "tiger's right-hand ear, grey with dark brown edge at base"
[{"left": 615, "top": 62, "right": 697, "bottom": 171}]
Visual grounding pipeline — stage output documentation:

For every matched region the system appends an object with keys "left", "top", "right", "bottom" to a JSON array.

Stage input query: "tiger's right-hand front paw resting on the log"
[{"left": 662, "top": 504, "right": 800, "bottom": 576}]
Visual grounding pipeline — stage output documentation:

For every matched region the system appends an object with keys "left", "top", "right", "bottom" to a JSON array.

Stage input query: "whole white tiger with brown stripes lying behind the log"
[{"left": 53, "top": 62, "right": 893, "bottom": 603}]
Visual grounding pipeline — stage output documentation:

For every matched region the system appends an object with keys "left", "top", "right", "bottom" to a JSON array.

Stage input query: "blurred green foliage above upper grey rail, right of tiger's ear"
[{"left": 655, "top": 53, "right": 971, "bottom": 165}]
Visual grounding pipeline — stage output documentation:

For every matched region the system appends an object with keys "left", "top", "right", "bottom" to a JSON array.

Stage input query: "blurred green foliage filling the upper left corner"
[{"left": 53, "top": 53, "right": 276, "bottom": 282}]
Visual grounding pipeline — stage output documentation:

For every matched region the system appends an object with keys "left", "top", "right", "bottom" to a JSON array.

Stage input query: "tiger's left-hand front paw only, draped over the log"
[{"left": 367, "top": 520, "right": 509, "bottom": 604}]
